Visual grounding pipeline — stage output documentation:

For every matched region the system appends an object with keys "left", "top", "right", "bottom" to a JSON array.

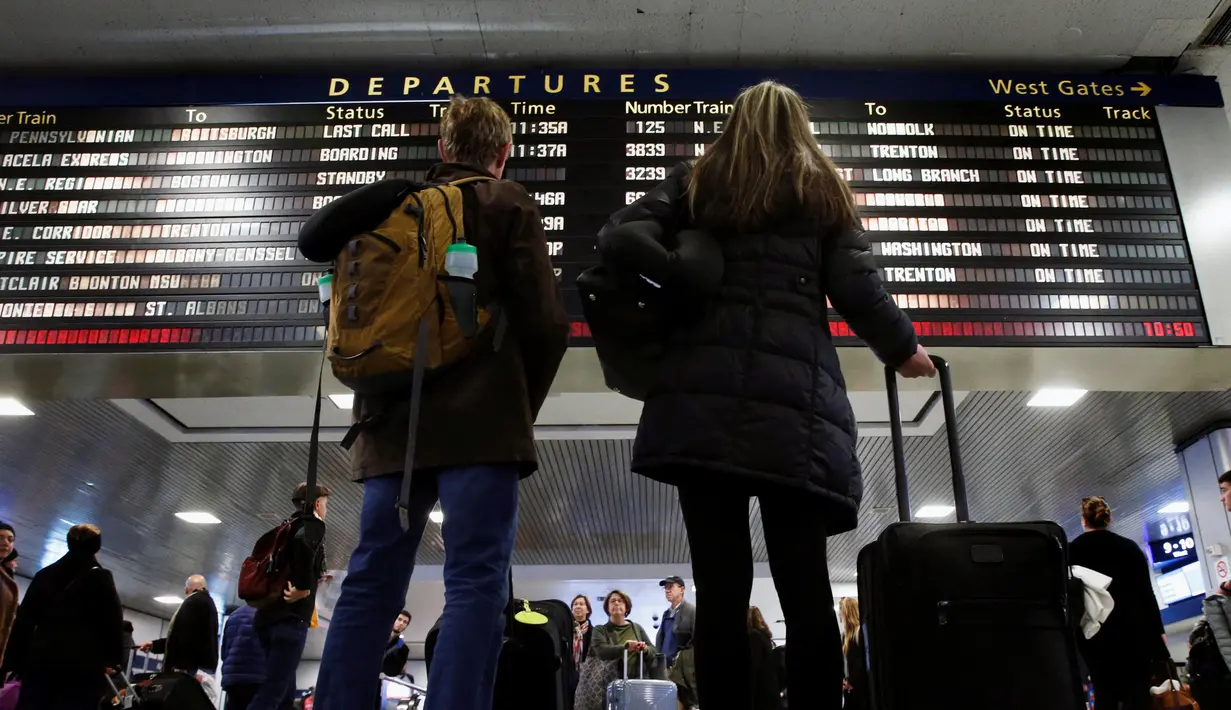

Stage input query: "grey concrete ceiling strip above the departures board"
[{"left": 0, "top": 0, "right": 1220, "bottom": 71}]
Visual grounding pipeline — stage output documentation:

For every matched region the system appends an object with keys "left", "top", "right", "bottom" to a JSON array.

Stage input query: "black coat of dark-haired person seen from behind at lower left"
[{"left": 5, "top": 552, "right": 124, "bottom": 683}]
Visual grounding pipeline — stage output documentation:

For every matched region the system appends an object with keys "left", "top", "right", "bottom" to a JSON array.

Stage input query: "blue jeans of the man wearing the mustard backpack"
[{"left": 313, "top": 466, "right": 519, "bottom": 710}]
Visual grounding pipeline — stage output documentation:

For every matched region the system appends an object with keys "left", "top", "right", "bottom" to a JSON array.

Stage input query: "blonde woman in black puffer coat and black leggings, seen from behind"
[{"left": 602, "top": 81, "right": 934, "bottom": 710}]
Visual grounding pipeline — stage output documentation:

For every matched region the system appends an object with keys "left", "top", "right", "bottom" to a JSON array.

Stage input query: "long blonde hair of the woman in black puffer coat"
[{"left": 688, "top": 81, "right": 858, "bottom": 231}]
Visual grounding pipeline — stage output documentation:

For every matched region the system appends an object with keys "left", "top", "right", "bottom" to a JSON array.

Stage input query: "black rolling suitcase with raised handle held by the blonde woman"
[{"left": 859, "top": 357, "right": 1086, "bottom": 710}]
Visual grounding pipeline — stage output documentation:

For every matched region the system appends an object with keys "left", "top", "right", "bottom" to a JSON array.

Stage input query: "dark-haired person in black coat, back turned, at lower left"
[{"left": 6, "top": 525, "right": 124, "bottom": 710}]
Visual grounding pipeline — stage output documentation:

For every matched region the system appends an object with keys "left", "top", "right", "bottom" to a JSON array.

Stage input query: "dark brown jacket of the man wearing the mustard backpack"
[{"left": 299, "top": 162, "right": 569, "bottom": 480}]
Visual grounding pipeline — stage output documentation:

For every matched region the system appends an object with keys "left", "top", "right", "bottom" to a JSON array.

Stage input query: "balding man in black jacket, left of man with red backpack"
[{"left": 139, "top": 575, "right": 218, "bottom": 676}]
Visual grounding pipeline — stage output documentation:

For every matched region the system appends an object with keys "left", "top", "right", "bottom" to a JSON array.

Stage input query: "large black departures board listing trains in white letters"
[{"left": 0, "top": 67, "right": 1210, "bottom": 352}]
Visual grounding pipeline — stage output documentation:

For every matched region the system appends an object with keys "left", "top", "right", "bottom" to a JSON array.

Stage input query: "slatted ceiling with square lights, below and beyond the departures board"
[{"left": 0, "top": 391, "right": 1231, "bottom": 614}]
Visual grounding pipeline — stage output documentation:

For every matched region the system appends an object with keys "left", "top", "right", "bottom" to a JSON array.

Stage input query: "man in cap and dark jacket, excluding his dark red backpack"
[{"left": 249, "top": 484, "right": 331, "bottom": 710}]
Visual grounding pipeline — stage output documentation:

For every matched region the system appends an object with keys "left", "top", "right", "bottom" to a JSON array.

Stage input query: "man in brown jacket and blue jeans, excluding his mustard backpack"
[{"left": 299, "top": 98, "right": 569, "bottom": 710}]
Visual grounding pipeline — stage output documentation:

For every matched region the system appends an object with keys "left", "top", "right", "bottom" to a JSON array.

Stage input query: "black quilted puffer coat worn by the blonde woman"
[{"left": 604, "top": 165, "right": 917, "bottom": 534}]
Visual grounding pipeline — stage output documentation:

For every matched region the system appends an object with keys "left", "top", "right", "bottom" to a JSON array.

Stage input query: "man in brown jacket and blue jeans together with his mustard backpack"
[{"left": 299, "top": 97, "right": 569, "bottom": 710}]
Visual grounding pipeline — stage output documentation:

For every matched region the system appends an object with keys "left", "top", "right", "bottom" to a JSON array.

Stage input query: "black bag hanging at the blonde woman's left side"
[{"left": 577, "top": 221, "right": 723, "bottom": 401}]
